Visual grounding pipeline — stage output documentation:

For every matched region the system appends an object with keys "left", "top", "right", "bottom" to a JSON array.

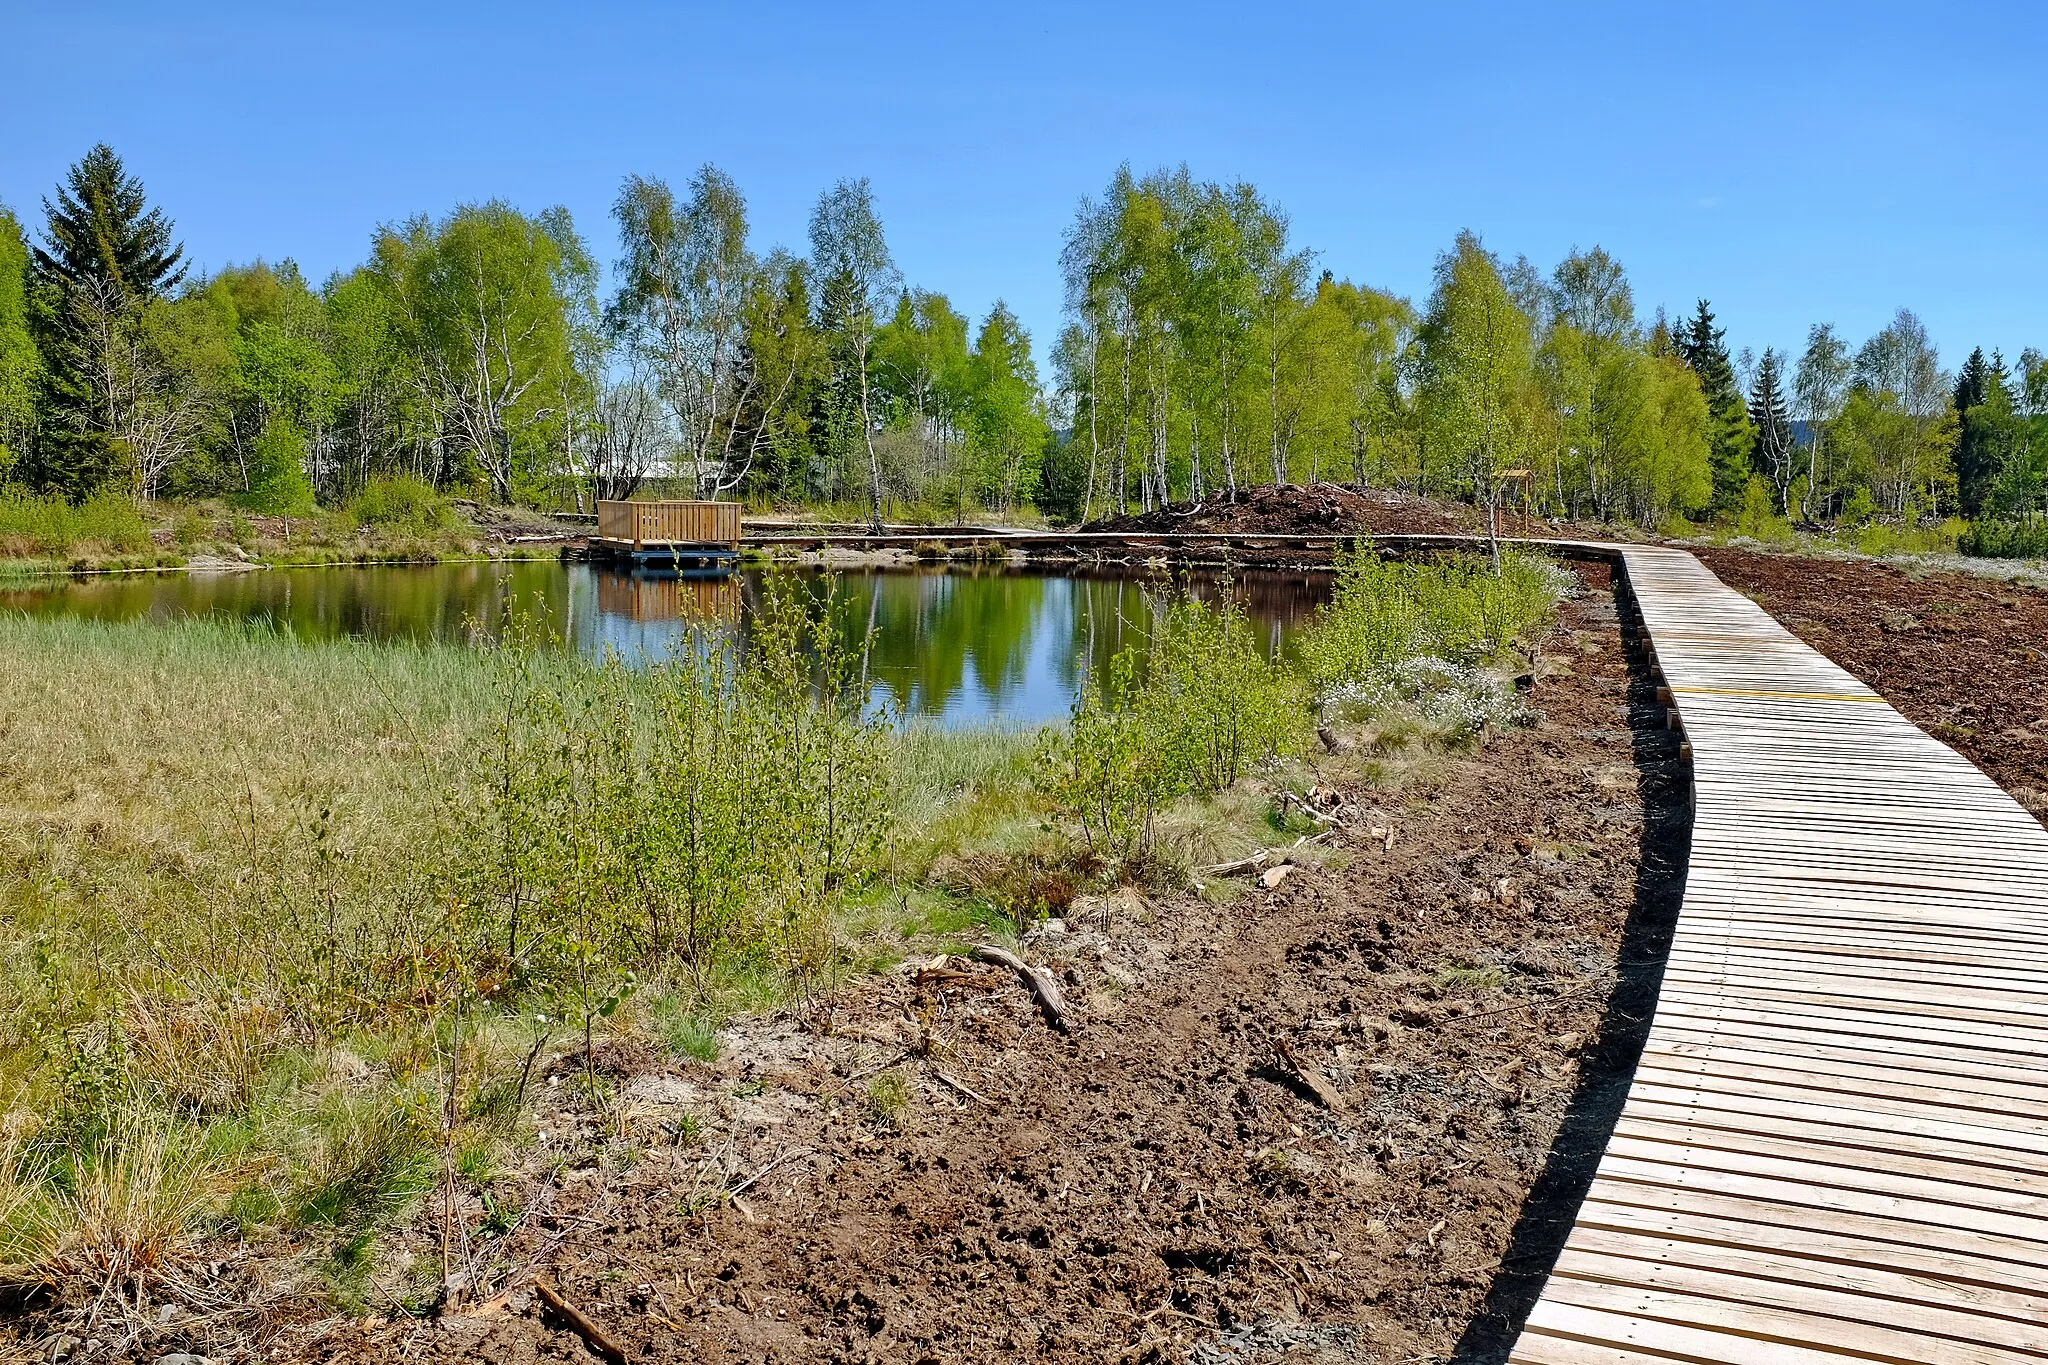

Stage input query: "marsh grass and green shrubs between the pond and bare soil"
[{"left": 0, "top": 557, "right": 1563, "bottom": 1350}]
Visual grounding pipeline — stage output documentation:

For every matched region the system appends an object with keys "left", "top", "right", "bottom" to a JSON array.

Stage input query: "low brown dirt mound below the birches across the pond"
[{"left": 1081, "top": 483, "right": 1483, "bottom": 536}]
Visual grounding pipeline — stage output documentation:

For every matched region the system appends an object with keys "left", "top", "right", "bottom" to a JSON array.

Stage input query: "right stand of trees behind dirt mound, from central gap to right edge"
[{"left": 1055, "top": 168, "right": 2048, "bottom": 526}]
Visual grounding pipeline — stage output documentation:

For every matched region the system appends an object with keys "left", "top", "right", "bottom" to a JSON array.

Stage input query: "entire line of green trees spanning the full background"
[{"left": 0, "top": 145, "right": 2048, "bottom": 526}]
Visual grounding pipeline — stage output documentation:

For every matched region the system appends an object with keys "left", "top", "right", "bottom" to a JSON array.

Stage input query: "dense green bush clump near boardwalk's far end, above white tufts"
[{"left": 1300, "top": 551, "right": 1559, "bottom": 698}]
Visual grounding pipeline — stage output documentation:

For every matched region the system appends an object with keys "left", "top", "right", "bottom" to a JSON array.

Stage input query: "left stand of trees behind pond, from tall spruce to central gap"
[{"left": 0, "top": 145, "right": 1051, "bottom": 518}]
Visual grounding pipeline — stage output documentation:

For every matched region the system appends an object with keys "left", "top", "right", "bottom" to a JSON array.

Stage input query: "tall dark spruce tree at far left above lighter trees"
[{"left": 27, "top": 143, "right": 184, "bottom": 497}]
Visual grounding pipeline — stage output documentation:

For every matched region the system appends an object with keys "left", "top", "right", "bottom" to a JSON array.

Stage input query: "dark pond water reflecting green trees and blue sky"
[{"left": 0, "top": 561, "right": 1329, "bottom": 724}]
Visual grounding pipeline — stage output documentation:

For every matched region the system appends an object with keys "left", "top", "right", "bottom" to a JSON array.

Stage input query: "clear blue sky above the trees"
[{"left": 0, "top": 0, "right": 2048, "bottom": 366}]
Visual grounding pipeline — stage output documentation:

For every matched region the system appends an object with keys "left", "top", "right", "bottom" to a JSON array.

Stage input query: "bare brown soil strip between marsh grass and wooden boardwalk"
[{"left": 266, "top": 567, "right": 1688, "bottom": 1365}]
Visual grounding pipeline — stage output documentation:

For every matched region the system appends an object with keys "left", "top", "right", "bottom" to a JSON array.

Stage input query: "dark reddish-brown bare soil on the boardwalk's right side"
[{"left": 1694, "top": 548, "right": 2048, "bottom": 823}]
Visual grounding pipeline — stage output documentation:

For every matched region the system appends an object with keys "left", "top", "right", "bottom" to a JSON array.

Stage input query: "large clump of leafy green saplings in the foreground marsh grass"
[{"left": 459, "top": 583, "right": 891, "bottom": 1002}]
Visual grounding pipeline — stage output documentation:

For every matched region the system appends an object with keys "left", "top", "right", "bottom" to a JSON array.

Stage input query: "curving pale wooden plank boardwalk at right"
[{"left": 1509, "top": 546, "right": 2048, "bottom": 1365}]
